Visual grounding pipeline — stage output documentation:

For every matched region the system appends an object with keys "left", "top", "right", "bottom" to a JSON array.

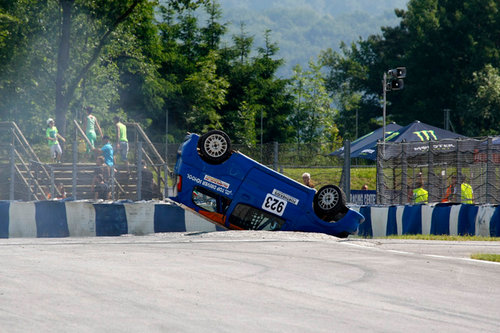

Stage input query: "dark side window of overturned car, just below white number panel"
[{"left": 229, "top": 204, "right": 285, "bottom": 230}]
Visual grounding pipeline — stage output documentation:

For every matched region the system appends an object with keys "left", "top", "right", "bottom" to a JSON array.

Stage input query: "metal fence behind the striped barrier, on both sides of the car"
[{"left": 6, "top": 132, "right": 500, "bottom": 205}]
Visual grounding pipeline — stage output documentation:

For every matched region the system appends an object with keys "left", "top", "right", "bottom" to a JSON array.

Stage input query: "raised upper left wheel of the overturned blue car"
[{"left": 198, "top": 130, "right": 231, "bottom": 164}]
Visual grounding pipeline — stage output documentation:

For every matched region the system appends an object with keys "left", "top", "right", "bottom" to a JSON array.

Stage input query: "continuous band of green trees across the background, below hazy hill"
[{"left": 0, "top": 0, "right": 500, "bottom": 156}]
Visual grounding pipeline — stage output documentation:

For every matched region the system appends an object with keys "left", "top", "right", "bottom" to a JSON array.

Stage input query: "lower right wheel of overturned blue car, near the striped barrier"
[{"left": 313, "top": 185, "right": 346, "bottom": 221}]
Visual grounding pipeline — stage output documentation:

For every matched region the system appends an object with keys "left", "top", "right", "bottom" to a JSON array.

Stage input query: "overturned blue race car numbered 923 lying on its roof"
[{"left": 170, "top": 130, "right": 364, "bottom": 238}]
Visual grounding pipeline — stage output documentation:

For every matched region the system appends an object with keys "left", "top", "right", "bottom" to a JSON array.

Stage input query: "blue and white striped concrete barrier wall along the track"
[{"left": 0, "top": 201, "right": 500, "bottom": 238}]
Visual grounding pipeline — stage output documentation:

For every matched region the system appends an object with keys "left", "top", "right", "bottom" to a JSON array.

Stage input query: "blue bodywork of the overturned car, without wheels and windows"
[{"left": 170, "top": 134, "right": 364, "bottom": 237}]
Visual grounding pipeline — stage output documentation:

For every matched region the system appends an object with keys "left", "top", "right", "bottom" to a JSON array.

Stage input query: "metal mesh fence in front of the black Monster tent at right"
[{"left": 377, "top": 137, "right": 500, "bottom": 205}]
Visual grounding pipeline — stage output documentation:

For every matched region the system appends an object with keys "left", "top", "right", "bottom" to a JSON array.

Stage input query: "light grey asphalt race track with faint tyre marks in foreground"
[{"left": 0, "top": 231, "right": 500, "bottom": 333}]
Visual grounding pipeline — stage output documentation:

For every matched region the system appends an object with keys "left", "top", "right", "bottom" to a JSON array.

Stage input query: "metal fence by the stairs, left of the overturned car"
[{"left": 0, "top": 141, "right": 170, "bottom": 201}]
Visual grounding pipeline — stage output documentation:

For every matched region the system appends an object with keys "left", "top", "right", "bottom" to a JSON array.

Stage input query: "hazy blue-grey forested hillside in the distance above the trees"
[{"left": 220, "top": 0, "right": 407, "bottom": 76}]
